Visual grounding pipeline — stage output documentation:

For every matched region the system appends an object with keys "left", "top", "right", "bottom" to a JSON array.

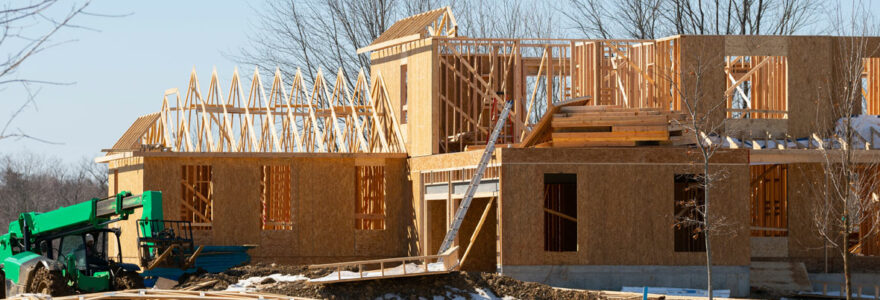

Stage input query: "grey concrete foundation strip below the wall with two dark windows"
[{"left": 502, "top": 265, "right": 749, "bottom": 297}]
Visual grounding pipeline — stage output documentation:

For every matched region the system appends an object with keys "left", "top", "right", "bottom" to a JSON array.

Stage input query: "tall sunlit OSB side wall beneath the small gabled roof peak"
[{"left": 370, "top": 38, "right": 440, "bottom": 156}]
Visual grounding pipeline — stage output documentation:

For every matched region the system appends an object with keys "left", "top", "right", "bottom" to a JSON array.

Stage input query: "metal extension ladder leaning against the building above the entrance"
[{"left": 438, "top": 101, "right": 513, "bottom": 254}]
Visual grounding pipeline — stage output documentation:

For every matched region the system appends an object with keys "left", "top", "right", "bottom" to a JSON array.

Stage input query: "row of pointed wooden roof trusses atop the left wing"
[{"left": 115, "top": 70, "right": 406, "bottom": 153}]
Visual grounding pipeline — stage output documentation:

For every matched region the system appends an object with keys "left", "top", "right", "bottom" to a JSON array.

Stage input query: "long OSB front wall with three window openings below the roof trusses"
[{"left": 109, "top": 155, "right": 414, "bottom": 263}]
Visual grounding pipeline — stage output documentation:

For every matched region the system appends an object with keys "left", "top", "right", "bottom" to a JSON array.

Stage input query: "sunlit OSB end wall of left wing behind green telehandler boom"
[{"left": 107, "top": 157, "right": 144, "bottom": 263}]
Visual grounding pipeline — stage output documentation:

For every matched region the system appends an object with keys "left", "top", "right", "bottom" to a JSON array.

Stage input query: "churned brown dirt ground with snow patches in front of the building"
[{"left": 176, "top": 264, "right": 600, "bottom": 300}]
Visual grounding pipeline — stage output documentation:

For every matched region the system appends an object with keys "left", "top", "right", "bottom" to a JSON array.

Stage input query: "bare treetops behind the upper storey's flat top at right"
[{"left": 560, "top": 0, "right": 822, "bottom": 39}]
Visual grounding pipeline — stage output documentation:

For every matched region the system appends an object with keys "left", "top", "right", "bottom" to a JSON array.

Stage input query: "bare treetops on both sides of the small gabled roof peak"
[{"left": 233, "top": 0, "right": 555, "bottom": 86}]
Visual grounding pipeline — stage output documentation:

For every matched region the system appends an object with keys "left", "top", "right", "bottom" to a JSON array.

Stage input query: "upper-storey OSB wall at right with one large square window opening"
[{"left": 679, "top": 35, "right": 880, "bottom": 137}]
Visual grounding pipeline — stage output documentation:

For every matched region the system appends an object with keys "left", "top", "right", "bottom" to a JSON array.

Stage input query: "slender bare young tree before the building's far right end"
[{"left": 811, "top": 1, "right": 880, "bottom": 299}]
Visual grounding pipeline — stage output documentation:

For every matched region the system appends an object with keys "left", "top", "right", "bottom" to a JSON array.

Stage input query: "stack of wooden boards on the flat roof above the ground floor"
[{"left": 534, "top": 105, "right": 695, "bottom": 147}]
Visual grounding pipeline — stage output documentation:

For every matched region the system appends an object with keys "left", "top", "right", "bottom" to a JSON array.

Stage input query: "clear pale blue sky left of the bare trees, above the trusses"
[{"left": 0, "top": 0, "right": 259, "bottom": 161}]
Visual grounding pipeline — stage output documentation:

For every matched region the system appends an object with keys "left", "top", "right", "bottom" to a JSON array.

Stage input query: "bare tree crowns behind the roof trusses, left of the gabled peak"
[{"left": 234, "top": 0, "right": 398, "bottom": 86}]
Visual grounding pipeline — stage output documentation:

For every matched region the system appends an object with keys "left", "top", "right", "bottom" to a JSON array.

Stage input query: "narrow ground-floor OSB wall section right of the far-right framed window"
[{"left": 787, "top": 164, "right": 825, "bottom": 258}]
